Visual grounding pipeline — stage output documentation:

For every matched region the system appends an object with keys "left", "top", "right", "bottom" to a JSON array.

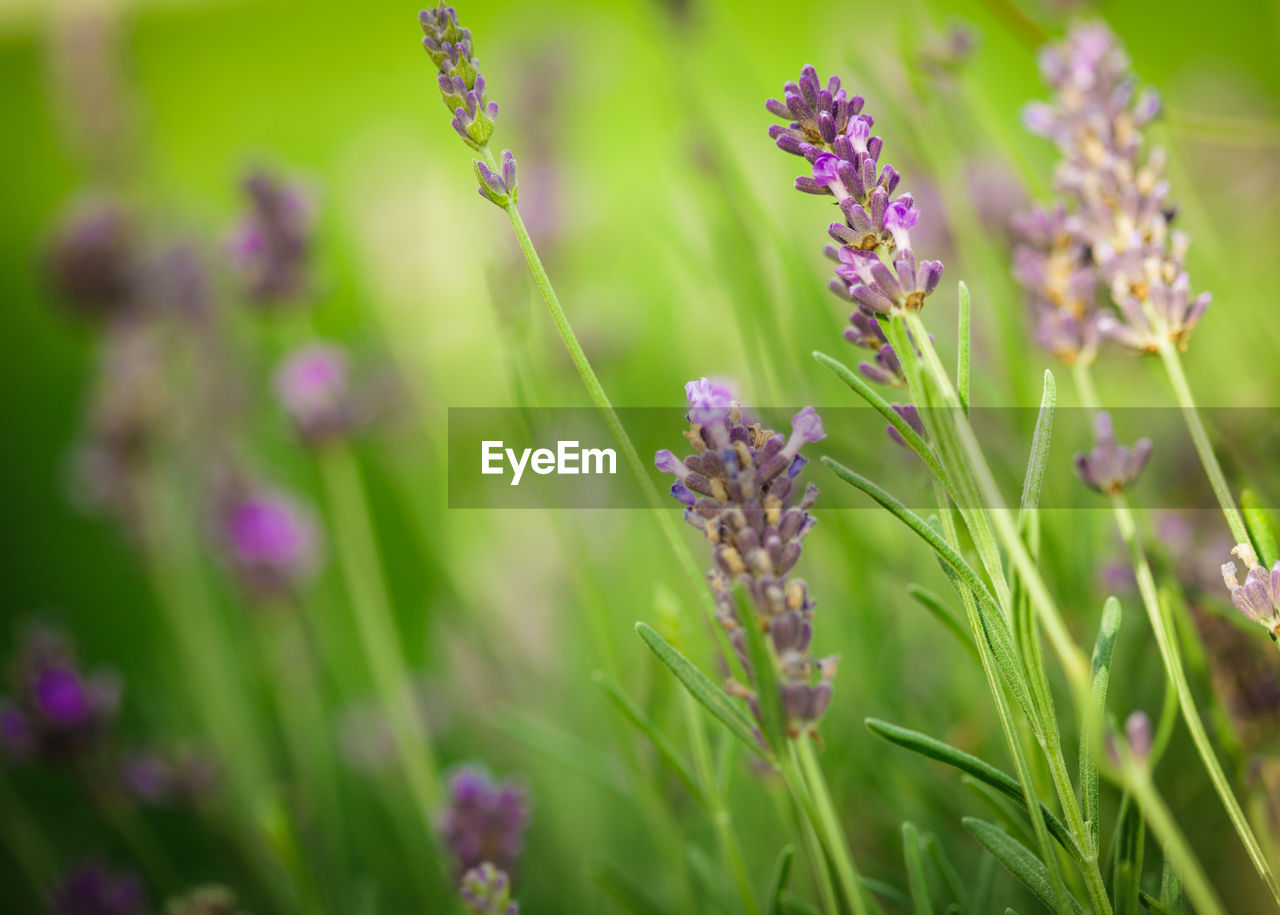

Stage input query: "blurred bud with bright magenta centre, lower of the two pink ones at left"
[{"left": 221, "top": 490, "right": 320, "bottom": 596}]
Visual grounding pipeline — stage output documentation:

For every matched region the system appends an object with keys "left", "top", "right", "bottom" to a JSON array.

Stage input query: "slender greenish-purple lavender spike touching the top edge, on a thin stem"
[{"left": 417, "top": 4, "right": 516, "bottom": 209}]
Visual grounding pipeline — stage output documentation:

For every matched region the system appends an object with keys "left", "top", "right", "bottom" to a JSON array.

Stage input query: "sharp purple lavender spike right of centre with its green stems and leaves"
[{"left": 767, "top": 67, "right": 1110, "bottom": 911}]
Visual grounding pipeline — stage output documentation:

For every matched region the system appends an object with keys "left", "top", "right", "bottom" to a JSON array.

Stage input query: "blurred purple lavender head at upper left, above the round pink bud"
[{"left": 228, "top": 171, "right": 312, "bottom": 305}]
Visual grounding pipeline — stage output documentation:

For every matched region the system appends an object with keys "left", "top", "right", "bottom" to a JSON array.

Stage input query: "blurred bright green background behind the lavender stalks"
[{"left": 0, "top": 0, "right": 1280, "bottom": 912}]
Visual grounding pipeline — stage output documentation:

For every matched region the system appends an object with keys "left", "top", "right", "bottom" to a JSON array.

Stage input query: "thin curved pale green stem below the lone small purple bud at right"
[{"left": 1111, "top": 494, "right": 1280, "bottom": 905}]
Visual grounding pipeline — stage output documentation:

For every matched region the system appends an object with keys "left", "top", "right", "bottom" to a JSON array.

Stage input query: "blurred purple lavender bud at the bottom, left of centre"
[{"left": 440, "top": 767, "right": 529, "bottom": 878}]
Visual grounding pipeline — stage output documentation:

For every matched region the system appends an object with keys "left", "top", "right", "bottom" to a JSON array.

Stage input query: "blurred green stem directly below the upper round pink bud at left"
[{"left": 319, "top": 443, "right": 442, "bottom": 836}]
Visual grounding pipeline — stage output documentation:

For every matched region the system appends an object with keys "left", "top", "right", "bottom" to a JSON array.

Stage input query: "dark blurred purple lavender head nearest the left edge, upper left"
[{"left": 46, "top": 200, "right": 138, "bottom": 317}]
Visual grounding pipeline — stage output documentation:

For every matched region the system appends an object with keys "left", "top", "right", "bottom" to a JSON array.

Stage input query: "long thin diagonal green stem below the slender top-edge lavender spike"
[{"left": 480, "top": 146, "right": 716, "bottom": 627}]
